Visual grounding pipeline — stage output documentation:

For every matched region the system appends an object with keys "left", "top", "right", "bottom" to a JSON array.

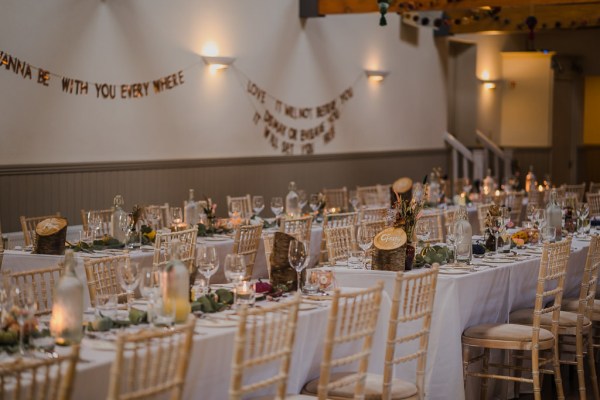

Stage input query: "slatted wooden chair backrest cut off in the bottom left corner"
[{"left": 0, "top": 345, "right": 79, "bottom": 400}]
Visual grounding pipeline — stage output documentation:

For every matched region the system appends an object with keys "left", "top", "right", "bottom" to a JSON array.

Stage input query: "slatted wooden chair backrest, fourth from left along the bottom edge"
[{"left": 317, "top": 281, "right": 383, "bottom": 400}]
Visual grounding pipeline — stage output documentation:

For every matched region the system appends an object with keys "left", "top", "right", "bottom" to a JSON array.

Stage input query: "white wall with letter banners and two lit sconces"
[{"left": 0, "top": 0, "right": 446, "bottom": 165}]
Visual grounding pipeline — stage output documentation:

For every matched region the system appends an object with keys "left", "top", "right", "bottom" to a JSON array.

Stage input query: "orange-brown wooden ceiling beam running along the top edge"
[{"left": 316, "top": 0, "right": 600, "bottom": 15}]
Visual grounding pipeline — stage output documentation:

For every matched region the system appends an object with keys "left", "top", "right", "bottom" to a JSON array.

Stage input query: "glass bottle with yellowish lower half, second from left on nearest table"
[{"left": 160, "top": 239, "right": 192, "bottom": 323}]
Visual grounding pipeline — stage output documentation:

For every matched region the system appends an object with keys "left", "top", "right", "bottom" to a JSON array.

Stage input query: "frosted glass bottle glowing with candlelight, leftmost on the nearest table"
[{"left": 50, "top": 249, "right": 83, "bottom": 345}]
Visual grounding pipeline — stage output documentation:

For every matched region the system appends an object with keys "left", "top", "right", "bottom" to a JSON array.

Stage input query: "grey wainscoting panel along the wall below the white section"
[{"left": 0, "top": 149, "right": 448, "bottom": 232}]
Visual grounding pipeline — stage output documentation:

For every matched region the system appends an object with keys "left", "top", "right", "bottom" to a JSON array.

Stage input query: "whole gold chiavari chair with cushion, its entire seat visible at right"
[{"left": 462, "top": 239, "right": 571, "bottom": 400}]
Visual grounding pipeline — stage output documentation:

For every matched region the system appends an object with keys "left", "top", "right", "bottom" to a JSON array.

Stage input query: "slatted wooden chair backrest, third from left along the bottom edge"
[{"left": 229, "top": 293, "right": 300, "bottom": 400}]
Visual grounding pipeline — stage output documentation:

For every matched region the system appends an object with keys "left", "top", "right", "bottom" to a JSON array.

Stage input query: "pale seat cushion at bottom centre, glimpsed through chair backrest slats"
[{"left": 302, "top": 372, "right": 418, "bottom": 400}]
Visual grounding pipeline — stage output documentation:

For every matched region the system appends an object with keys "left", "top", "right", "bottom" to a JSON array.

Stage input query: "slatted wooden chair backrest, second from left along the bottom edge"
[{"left": 107, "top": 314, "right": 196, "bottom": 400}]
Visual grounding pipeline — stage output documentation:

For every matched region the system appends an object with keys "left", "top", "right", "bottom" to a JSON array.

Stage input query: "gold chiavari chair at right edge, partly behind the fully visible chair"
[{"left": 510, "top": 235, "right": 600, "bottom": 400}]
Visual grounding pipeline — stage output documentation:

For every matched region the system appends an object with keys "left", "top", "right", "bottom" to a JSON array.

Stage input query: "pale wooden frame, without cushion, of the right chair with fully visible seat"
[{"left": 462, "top": 238, "right": 571, "bottom": 400}]
